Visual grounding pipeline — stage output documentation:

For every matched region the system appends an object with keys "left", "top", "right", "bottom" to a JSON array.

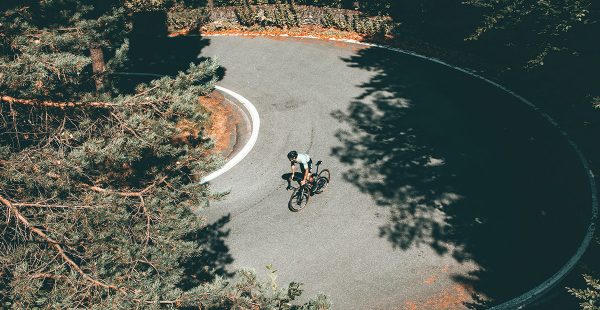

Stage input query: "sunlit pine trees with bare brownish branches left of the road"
[{"left": 0, "top": 0, "right": 329, "bottom": 309}]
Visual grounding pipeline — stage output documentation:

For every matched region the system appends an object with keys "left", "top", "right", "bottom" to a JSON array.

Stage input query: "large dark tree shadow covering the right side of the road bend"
[{"left": 332, "top": 48, "right": 590, "bottom": 308}]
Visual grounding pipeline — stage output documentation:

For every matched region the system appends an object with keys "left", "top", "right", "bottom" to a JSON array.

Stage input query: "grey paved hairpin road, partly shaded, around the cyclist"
[{"left": 202, "top": 37, "right": 589, "bottom": 309}]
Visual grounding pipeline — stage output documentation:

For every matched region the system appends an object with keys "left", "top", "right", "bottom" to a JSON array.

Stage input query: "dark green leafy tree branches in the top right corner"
[{"left": 467, "top": 0, "right": 600, "bottom": 107}]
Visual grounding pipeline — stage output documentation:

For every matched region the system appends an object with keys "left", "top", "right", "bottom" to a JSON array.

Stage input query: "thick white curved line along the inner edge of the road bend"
[{"left": 200, "top": 85, "right": 260, "bottom": 184}]
